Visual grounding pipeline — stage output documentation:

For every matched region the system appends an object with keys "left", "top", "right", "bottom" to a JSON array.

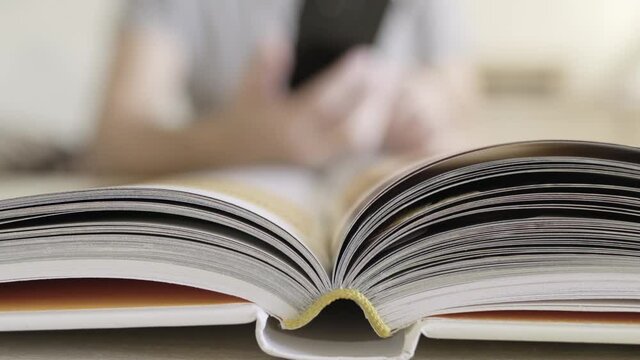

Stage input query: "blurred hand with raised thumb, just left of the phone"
[{"left": 208, "top": 38, "right": 384, "bottom": 166}]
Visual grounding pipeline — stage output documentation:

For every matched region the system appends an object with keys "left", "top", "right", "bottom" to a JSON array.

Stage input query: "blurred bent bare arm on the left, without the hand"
[{"left": 87, "top": 30, "right": 245, "bottom": 174}]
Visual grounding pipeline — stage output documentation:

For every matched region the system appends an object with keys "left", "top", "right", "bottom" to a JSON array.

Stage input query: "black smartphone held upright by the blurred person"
[{"left": 290, "top": 0, "right": 389, "bottom": 88}]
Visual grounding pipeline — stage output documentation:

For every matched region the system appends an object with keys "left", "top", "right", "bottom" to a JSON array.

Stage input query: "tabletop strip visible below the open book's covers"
[{"left": 0, "top": 324, "right": 640, "bottom": 360}]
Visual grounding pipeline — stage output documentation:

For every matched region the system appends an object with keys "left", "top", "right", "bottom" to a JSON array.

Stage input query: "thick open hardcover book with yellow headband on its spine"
[{"left": 0, "top": 141, "right": 640, "bottom": 358}]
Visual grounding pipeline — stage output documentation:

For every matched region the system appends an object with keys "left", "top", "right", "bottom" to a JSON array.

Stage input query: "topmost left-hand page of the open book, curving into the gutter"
[{"left": 143, "top": 166, "right": 331, "bottom": 271}]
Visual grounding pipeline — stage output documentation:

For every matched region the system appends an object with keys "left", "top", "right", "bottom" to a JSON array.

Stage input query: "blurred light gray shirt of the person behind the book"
[{"left": 125, "top": 0, "right": 465, "bottom": 114}]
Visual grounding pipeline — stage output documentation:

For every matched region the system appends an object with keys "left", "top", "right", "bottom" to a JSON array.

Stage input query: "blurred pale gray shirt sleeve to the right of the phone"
[{"left": 416, "top": 0, "right": 470, "bottom": 65}]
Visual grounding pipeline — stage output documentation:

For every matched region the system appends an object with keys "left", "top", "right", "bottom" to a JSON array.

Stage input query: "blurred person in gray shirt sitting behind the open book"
[{"left": 90, "top": 0, "right": 471, "bottom": 175}]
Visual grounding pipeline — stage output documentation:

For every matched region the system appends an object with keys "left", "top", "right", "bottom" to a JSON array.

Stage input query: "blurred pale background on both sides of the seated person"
[{"left": 0, "top": 0, "right": 640, "bottom": 191}]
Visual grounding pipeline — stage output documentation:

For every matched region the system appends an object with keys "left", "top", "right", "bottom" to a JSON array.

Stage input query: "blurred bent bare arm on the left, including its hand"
[{"left": 87, "top": 28, "right": 376, "bottom": 175}]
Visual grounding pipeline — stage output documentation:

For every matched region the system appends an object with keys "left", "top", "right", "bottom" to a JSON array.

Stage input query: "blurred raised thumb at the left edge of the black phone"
[{"left": 241, "top": 37, "right": 292, "bottom": 101}]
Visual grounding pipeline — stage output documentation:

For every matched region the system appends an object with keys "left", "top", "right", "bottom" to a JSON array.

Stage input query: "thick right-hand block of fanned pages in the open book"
[{"left": 334, "top": 141, "right": 640, "bottom": 329}]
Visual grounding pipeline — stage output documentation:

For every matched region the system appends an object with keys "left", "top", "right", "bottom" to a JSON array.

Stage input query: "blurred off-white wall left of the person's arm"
[{"left": 0, "top": 0, "right": 118, "bottom": 143}]
